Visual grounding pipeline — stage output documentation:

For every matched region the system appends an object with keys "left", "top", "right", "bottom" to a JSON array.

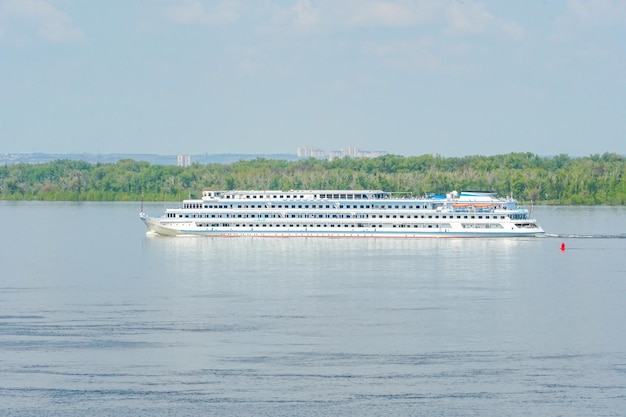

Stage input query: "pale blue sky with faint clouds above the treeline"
[{"left": 0, "top": 0, "right": 626, "bottom": 157}]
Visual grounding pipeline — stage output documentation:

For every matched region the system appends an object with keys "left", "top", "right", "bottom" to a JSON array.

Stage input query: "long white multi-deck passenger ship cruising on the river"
[{"left": 140, "top": 190, "right": 544, "bottom": 238}]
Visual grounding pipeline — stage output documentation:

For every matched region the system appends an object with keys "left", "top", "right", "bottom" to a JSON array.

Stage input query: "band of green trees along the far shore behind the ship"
[{"left": 0, "top": 153, "right": 626, "bottom": 205}]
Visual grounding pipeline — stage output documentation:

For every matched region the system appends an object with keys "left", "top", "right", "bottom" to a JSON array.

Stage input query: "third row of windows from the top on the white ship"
[{"left": 167, "top": 213, "right": 508, "bottom": 219}]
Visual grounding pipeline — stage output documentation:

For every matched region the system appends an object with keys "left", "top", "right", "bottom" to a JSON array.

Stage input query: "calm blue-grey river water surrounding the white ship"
[{"left": 0, "top": 202, "right": 626, "bottom": 416}]
